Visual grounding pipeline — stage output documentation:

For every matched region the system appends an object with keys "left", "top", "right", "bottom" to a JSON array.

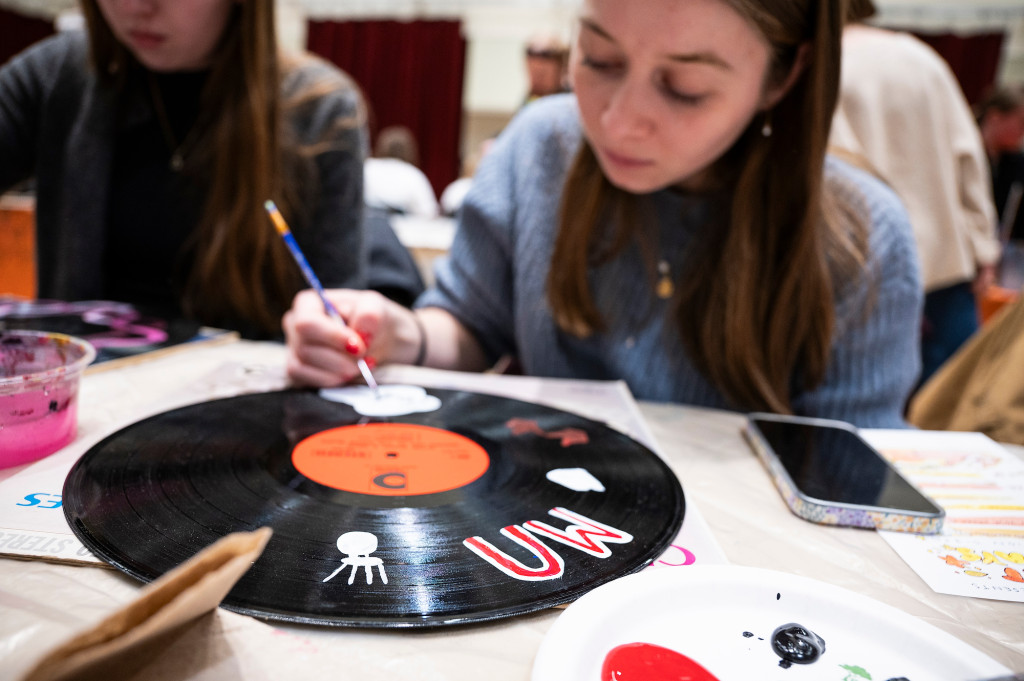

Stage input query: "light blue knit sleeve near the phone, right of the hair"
[{"left": 794, "top": 161, "right": 923, "bottom": 428}]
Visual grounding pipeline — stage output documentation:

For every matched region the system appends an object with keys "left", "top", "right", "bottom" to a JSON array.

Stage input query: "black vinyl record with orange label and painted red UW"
[{"left": 63, "top": 389, "right": 684, "bottom": 627}]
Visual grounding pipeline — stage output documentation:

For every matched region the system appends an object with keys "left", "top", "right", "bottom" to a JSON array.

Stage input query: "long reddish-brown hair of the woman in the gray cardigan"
[{"left": 82, "top": 0, "right": 342, "bottom": 335}]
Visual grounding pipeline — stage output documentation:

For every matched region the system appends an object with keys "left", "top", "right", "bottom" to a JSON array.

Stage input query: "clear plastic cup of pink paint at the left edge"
[{"left": 0, "top": 331, "right": 96, "bottom": 468}]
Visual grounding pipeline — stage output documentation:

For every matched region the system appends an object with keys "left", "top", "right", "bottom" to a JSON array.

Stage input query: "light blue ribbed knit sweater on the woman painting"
[{"left": 417, "top": 95, "right": 922, "bottom": 427}]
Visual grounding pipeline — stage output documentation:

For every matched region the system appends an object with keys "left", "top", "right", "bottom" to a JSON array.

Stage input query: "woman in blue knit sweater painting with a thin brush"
[{"left": 285, "top": 0, "right": 922, "bottom": 426}]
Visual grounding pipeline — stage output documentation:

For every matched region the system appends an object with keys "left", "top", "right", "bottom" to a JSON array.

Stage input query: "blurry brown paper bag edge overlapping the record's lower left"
[{"left": 22, "top": 527, "right": 271, "bottom": 681}]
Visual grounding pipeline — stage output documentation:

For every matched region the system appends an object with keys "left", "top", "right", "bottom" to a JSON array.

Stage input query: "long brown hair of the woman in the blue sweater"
[{"left": 548, "top": 0, "right": 866, "bottom": 413}]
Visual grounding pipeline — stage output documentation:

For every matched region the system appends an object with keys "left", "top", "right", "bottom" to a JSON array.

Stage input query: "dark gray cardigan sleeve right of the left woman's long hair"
[{"left": 285, "top": 58, "right": 368, "bottom": 289}]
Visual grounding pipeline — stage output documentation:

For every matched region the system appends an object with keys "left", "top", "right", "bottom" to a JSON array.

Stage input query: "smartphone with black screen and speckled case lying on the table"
[{"left": 743, "top": 414, "right": 945, "bottom": 535}]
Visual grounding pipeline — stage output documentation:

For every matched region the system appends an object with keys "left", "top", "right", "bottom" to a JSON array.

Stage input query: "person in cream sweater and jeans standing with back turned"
[{"left": 829, "top": 0, "right": 1000, "bottom": 383}]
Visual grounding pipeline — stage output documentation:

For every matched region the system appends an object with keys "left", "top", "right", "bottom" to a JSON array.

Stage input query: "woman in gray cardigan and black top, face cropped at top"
[{"left": 0, "top": 0, "right": 367, "bottom": 338}]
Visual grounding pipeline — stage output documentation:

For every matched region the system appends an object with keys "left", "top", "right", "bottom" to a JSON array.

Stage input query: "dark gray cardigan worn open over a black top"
[{"left": 0, "top": 33, "right": 367, "bottom": 307}]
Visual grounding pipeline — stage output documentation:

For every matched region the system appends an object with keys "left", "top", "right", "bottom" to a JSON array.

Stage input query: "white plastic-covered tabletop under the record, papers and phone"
[{"left": 0, "top": 342, "right": 1024, "bottom": 681}]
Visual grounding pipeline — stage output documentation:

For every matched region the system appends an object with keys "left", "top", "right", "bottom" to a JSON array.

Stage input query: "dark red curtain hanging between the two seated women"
[{"left": 308, "top": 20, "right": 466, "bottom": 196}]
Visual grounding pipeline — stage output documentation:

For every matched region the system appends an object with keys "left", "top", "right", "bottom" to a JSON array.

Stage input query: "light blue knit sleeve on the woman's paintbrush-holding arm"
[{"left": 417, "top": 94, "right": 593, "bottom": 366}]
